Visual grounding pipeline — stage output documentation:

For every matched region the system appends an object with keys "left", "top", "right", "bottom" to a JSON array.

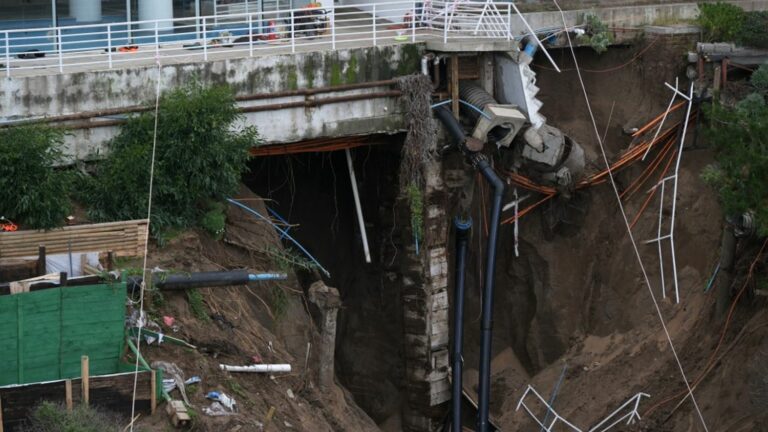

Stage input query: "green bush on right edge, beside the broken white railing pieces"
[{"left": 702, "top": 94, "right": 768, "bottom": 235}]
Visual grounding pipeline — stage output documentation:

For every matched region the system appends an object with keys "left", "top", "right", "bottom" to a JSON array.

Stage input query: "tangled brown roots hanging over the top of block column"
[{"left": 397, "top": 75, "right": 437, "bottom": 191}]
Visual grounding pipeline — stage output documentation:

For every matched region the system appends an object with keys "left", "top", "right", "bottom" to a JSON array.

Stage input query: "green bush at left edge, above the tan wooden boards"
[{"left": 0, "top": 125, "right": 74, "bottom": 229}]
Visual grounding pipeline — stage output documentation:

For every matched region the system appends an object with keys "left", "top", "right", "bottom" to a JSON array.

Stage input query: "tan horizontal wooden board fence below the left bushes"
[{"left": 0, "top": 219, "right": 148, "bottom": 258}]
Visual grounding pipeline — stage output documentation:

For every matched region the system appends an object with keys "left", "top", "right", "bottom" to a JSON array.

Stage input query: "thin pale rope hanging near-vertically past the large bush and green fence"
[{"left": 130, "top": 60, "right": 162, "bottom": 432}]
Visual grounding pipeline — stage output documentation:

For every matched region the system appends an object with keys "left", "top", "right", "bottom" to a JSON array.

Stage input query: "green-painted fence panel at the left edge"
[{"left": 0, "top": 283, "right": 126, "bottom": 385}]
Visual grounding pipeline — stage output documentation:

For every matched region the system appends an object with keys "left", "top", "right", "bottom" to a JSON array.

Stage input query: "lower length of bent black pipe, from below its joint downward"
[{"left": 472, "top": 154, "right": 505, "bottom": 432}]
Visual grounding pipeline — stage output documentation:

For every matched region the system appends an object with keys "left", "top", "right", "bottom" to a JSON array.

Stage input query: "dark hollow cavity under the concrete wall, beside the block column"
[{"left": 244, "top": 135, "right": 408, "bottom": 424}]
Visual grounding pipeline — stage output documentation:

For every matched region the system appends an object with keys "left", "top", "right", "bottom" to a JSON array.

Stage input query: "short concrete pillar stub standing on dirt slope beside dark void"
[{"left": 309, "top": 281, "right": 341, "bottom": 389}]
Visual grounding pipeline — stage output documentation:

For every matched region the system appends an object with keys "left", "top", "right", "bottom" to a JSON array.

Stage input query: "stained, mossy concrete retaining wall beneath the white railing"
[{"left": 0, "top": 44, "right": 423, "bottom": 159}]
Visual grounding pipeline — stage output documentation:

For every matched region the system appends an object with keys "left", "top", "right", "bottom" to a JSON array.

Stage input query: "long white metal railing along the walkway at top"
[{"left": 0, "top": 0, "right": 544, "bottom": 77}]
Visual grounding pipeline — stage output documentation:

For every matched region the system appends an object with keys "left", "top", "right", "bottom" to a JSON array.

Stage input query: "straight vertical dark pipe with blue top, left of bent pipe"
[{"left": 451, "top": 218, "right": 472, "bottom": 432}]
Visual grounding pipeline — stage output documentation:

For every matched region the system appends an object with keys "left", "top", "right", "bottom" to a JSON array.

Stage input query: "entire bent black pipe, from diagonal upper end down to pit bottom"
[{"left": 435, "top": 106, "right": 505, "bottom": 432}]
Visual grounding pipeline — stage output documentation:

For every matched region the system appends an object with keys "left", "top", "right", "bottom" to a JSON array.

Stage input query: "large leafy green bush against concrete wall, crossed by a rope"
[{"left": 81, "top": 82, "right": 259, "bottom": 240}]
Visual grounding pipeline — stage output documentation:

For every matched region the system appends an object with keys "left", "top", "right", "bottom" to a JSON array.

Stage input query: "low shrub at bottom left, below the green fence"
[{"left": 22, "top": 402, "right": 129, "bottom": 432}]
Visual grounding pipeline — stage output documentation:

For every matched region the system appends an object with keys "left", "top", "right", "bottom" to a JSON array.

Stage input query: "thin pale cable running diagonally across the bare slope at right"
[{"left": 552, "top": 0, "right": 709, "bottom": 432}]
